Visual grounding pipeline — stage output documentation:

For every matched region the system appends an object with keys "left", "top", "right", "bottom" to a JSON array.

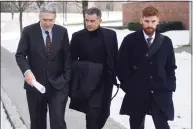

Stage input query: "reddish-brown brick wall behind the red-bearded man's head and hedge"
[{"left": 122, "top": 2, "right": 189, "bottom": 29}]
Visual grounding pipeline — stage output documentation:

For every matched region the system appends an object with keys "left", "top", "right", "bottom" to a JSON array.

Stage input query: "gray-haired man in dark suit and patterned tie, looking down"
[{"left": 15, "top": 2, "right": 71, "bottom": 129}]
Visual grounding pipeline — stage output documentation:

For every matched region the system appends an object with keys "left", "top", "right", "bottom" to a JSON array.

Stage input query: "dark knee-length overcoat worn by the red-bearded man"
[{"left": 116, "top": 30, "right": 177, "bottom": 120}]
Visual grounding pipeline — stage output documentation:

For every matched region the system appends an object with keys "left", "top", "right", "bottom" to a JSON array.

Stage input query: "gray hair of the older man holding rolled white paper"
[{"left": 40, "top": 2, "right": 57, "bottom": 14}]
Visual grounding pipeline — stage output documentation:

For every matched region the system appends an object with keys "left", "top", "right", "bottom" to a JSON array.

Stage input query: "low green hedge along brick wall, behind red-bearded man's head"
[{"left": 127, "top": 21, "right": 185, "bottom": 33}]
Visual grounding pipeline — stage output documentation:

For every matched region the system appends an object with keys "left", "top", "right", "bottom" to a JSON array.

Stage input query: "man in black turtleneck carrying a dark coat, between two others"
[{"left": 69, "top": 7, "right": 118, "bottom": 129}]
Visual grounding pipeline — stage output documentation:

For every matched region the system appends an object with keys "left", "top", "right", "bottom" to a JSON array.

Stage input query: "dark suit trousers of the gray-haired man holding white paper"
[{"left": 26, "top": 82, "right": 68, "bottom": 129}]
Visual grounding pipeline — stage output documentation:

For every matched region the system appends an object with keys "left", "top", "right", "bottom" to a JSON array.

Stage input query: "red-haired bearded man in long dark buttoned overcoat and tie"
[{"left": 116, "top": 6, "right": 177, "bottom": 129}]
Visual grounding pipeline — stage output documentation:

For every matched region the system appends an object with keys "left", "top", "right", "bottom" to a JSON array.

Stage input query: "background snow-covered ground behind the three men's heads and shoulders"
[{"left": 1, "top": 22, "right": 189, "bottom": 52}]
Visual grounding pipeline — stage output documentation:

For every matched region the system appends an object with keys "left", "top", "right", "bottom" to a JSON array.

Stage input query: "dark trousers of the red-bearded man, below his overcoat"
[{"left": 130, "top": 93, "right": 170, "bottom": 129}]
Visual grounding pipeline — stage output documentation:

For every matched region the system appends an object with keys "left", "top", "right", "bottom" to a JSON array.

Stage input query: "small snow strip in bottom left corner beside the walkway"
[{"left": 1, "top": 102, "right": 13, "bottom": 129}]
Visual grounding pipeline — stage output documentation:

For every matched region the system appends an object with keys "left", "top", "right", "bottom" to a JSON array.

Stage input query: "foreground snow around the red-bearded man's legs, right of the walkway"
[{"left": 111, "top": 52, "right": 191, "bottom": 129}]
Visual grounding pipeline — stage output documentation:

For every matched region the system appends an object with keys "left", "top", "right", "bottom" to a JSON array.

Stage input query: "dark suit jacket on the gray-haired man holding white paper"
[{"left": 15, "top": 22, "right": 71, "bottom": 90}]
